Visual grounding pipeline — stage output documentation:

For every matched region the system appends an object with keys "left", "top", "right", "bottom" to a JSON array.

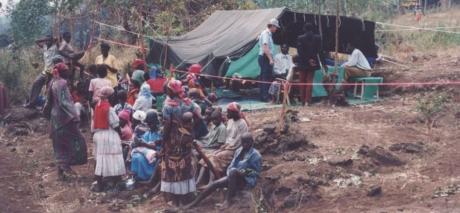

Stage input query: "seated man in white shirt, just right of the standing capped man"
[{"left": 268, "top": 44, "right": 294, "bottom": 103}]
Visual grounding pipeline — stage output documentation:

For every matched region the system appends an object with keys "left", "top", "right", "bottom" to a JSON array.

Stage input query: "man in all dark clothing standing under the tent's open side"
[{"left": 297, "top": 23, "right": 326, "bottom": 105}]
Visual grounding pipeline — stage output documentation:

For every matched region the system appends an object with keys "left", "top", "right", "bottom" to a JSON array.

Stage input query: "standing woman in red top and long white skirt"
[{"left": 92, "top": 87, "right": 126, "bottom": 192}]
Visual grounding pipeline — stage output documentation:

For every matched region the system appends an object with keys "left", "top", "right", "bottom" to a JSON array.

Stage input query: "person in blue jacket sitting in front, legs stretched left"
[{"left": 185, "top": 132, "right": 262, "bottom": 209}]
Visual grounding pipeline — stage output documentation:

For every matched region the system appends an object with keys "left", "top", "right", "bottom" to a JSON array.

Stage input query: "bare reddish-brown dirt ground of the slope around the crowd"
[{"left": 0, "top": 42, "right": 460, "bottom": 212}]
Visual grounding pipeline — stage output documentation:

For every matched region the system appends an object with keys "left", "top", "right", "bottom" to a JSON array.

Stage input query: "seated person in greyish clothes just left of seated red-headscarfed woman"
[{"left": 197, "top": 110, "right": 227, "bottom": 150}]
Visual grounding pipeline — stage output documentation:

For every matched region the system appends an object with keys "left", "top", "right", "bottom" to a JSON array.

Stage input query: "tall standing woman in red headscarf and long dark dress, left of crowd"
[{"left": 44, "top": 63, "right": 87, "bottom": 180}]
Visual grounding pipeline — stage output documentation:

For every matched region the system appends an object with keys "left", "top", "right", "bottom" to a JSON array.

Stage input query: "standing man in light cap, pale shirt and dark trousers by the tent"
[{"left": 258, "top": 18, "right": 280, "bottom": 102}]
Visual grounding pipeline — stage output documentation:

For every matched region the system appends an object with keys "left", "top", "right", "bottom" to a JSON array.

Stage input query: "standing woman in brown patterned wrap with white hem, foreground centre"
[{"left": 161, "top": 80, "right": 196, "bottom": 206}]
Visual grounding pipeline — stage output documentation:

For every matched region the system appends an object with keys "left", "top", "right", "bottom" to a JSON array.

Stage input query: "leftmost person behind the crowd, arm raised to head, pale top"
[{"left": 24, "top": 35, "right": 58, "bottom": 108}]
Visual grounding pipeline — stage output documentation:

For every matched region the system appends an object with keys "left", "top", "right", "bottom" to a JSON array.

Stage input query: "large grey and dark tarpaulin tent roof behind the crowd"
[{"left": 148, "top": 8, "right": 377, "bottom": 76}]
